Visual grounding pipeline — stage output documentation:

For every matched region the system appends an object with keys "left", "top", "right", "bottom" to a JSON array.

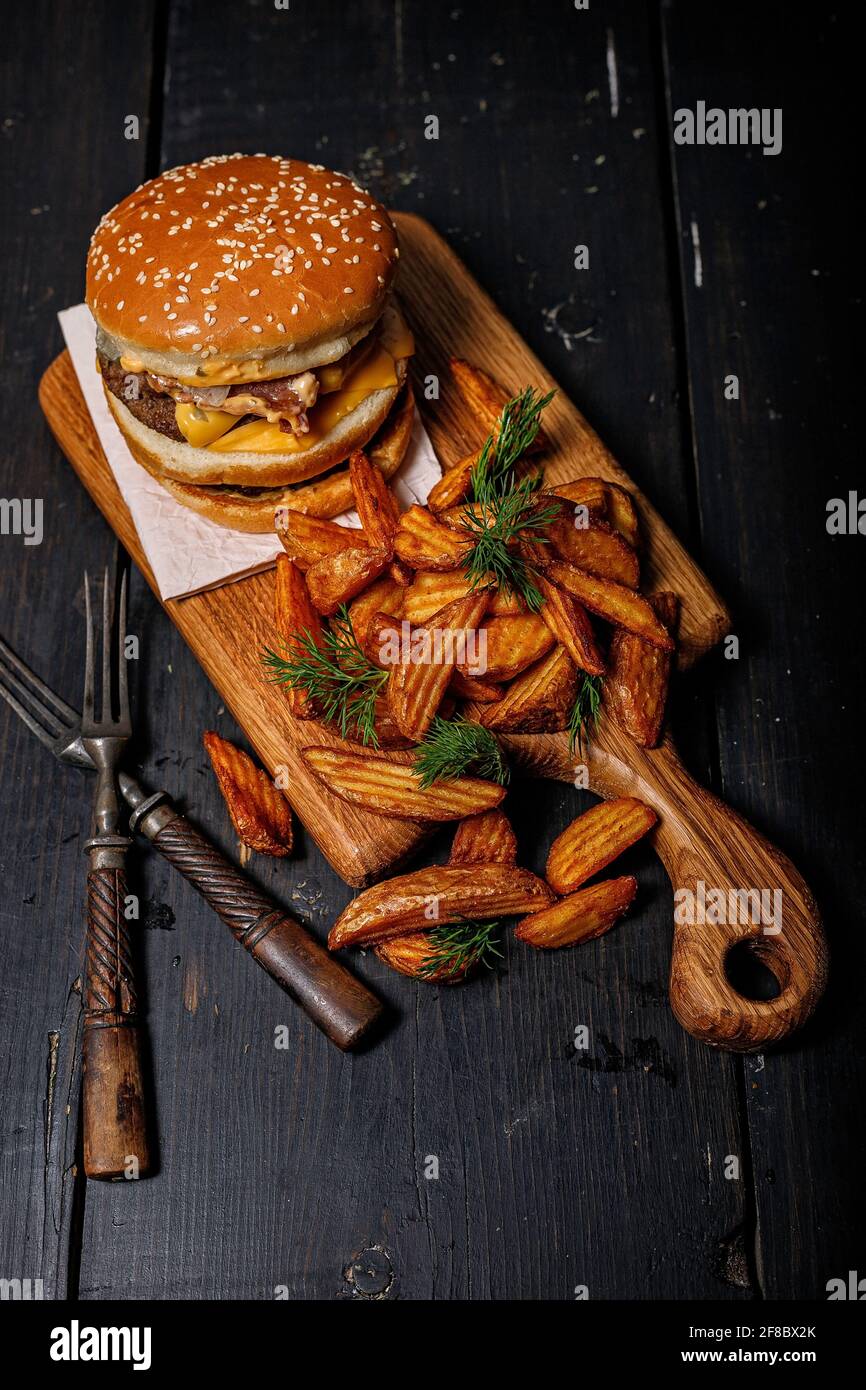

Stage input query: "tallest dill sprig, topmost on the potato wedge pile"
[{"left": 461, "top": 386, "right": 557, "bottom": 613}]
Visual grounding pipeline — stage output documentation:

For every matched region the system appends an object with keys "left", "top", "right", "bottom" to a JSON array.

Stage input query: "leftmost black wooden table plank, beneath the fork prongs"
[{"left": 0, "top": 0, "right": 153, "bottom": 1298}]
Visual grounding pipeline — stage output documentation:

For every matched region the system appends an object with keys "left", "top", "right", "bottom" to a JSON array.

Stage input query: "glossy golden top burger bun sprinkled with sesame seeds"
[{"left": 86, "top": 154, "right": 399, "bottom": 385}]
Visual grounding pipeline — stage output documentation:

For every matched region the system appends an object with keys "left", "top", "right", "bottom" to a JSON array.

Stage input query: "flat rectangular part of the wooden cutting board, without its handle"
[{"left": 39, "top": 214, "right": 728, "bottom": 885}]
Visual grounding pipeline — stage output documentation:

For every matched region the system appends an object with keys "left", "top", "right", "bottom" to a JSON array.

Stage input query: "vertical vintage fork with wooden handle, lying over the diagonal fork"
[{"left": 81, "top": 570, "right": 150, "bottom": 1179}]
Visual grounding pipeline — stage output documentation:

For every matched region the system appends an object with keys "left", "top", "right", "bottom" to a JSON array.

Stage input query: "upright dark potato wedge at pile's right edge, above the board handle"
[{"left": 605, "top": 592, "right": 678, "bottom": 748}]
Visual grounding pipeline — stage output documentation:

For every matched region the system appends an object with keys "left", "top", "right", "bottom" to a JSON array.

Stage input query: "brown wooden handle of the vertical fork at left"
[{"left": 82, "top": 867, "right": 150, "bottom": 1179}]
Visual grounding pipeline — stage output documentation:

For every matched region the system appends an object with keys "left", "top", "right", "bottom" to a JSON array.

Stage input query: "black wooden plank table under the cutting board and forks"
[{"left": 0, "top": 0, "right": 866, "bottom": 1300}]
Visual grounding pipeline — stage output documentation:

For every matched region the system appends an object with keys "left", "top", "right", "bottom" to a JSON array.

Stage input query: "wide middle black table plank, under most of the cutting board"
[{"left": 67, "top": 0, "right": 748, "bottom": 1298}]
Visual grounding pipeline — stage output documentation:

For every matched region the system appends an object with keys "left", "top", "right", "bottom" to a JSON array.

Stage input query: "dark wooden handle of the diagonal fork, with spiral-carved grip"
[{"left": 147, "top": 809, "right": 384, "bottom": 1051}]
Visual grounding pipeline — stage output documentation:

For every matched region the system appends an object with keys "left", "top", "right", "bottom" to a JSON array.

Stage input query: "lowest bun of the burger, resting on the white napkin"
[{"left": 139, "top": 379, "right": 414, "bottom": 531}]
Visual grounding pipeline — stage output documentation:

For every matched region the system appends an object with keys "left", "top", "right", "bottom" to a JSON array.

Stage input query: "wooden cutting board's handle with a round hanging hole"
[{"left": 506, "top": 720, "right": 827, "bottom": 1052}]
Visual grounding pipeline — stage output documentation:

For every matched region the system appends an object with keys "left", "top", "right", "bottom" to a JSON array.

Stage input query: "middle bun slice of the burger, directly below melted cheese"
[{"left": 106, "top": 357, "right": 407, "bottom": 488}]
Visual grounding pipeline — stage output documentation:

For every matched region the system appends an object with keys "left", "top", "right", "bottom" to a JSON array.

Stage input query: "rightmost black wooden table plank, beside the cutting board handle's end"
[{"left": 663, "top": 3, "right": 866, "bottom": 1298}]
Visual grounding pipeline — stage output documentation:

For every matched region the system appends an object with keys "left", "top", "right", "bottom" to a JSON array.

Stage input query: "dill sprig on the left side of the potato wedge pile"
[{"left": 261, "top": 603, "right": 388, "bottom": 748}]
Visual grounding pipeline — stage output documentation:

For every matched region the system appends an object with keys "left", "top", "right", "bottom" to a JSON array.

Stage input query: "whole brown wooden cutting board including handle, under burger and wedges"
[{"left": 39, "top": 214, "right": 826, "bottom": 1048}]
